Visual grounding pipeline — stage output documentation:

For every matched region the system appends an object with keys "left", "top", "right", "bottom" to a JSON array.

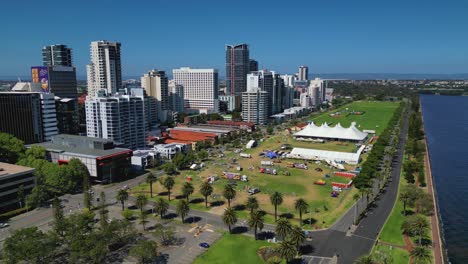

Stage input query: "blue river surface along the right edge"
[{"left": 420, "top": 95, "right": 468, "bottom": 263}]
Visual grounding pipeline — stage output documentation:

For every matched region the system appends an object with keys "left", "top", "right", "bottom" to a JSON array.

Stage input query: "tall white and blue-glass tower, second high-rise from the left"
[{"left": 86, "top": 40, "right": 122, "bottom": 97}]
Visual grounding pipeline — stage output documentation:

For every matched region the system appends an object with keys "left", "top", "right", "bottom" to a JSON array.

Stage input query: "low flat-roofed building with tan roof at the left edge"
[{"left": 0, "top": 162, "right": 37, "bottom": 212}]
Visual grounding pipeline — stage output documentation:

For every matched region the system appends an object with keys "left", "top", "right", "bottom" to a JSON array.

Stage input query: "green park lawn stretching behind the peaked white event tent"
[{"left": 312, "top": 101, "right": 399, "bottom": 135}]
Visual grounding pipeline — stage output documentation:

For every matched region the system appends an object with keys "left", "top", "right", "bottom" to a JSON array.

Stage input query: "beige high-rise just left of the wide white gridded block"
[{"left": 141, "top": 70, "right": 170, "bottom": 122}]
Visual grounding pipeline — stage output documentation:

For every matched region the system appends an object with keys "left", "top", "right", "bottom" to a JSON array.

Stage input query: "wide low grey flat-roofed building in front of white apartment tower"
[{"left": 33, "top": 134, "right": 132, "bottom": 183}]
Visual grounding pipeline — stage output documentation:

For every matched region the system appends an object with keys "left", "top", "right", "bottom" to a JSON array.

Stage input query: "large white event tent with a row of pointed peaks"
[{"left": 293, "top": 122, "right": 368, "bottom": 141}]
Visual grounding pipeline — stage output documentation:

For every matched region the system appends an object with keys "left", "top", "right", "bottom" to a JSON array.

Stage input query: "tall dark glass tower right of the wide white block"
[{"left": 226, "top": 44, "right": 250, "bottom": 95}]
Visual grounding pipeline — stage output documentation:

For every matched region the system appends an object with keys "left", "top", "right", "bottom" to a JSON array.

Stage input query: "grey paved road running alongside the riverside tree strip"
[{"left": 305, "top": 108, "right": 408, "bottom": 263}]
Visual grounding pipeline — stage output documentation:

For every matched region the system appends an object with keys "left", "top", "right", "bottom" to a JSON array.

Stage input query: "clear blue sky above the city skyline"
[{"left": 0, "top": 0, "right": 468, "bottom": 76}]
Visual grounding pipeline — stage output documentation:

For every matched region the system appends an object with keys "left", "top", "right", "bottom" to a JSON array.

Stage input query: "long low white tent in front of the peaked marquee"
[{"left": 287, "top": 145, "right": 366, "bottom": 164}]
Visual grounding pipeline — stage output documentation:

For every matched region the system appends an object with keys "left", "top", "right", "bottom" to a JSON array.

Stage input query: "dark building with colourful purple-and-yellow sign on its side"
[{"left": 31, "top": 66, "right": 78, "bottom": 99}]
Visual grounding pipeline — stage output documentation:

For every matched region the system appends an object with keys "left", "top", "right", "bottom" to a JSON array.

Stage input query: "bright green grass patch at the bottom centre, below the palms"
[{"left": 193, "top": 234, "right": 271, "bottom": 264}]
